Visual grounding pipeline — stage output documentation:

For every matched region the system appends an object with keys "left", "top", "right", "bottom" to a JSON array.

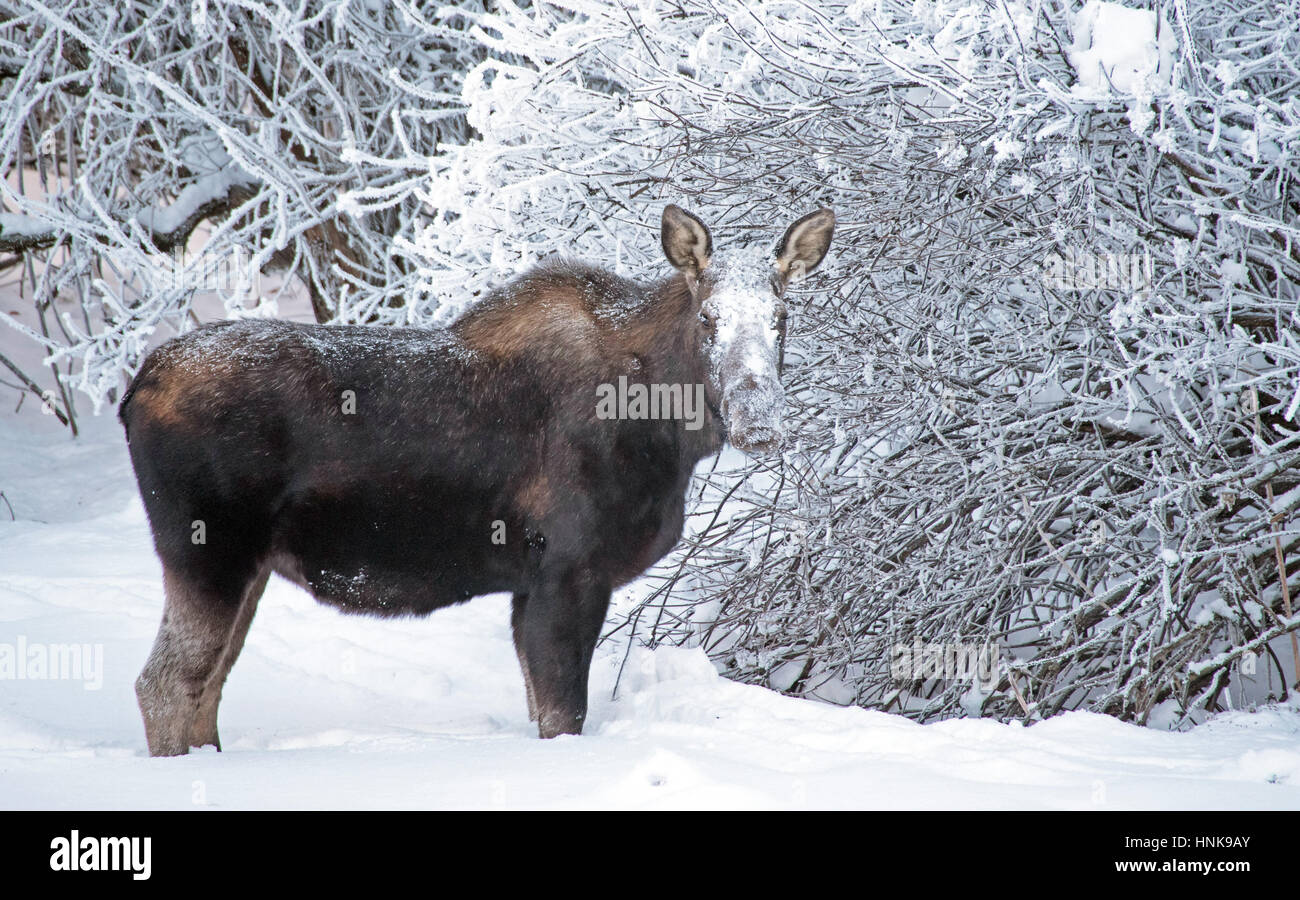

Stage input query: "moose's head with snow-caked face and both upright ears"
[{"left": 662, "top": 205, "right": 835, "bottom": 453}]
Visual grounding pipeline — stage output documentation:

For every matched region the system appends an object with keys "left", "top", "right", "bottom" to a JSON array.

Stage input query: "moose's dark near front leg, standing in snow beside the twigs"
[{"left": 521, "top": 568, "right": 610, "bottom": 737}]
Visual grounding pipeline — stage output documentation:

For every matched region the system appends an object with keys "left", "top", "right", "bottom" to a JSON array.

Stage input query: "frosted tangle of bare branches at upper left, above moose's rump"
[{"left": 0, "top": 0, "right": 482, "bottom": 417}]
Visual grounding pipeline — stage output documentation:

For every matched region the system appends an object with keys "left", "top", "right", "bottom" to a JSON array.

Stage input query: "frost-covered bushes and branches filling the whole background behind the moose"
[{"left": 0, "top": 0, "right": 1300, "bottom": 726}]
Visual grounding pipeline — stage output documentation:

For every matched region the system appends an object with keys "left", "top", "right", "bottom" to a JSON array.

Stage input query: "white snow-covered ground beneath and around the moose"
[{"left": 0, "top": 410, "right": 1300, "bottom": 809}]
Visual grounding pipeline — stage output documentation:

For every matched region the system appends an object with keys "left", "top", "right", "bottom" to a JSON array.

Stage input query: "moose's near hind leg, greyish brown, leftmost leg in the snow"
[{"left": 135, "top": 566, "right": 253, "bottom": 756}]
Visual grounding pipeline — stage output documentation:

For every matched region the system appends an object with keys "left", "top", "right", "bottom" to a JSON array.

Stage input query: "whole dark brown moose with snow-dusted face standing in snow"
[{"left": 118, "top": 205, "right": 835, "bottom": 756}]
